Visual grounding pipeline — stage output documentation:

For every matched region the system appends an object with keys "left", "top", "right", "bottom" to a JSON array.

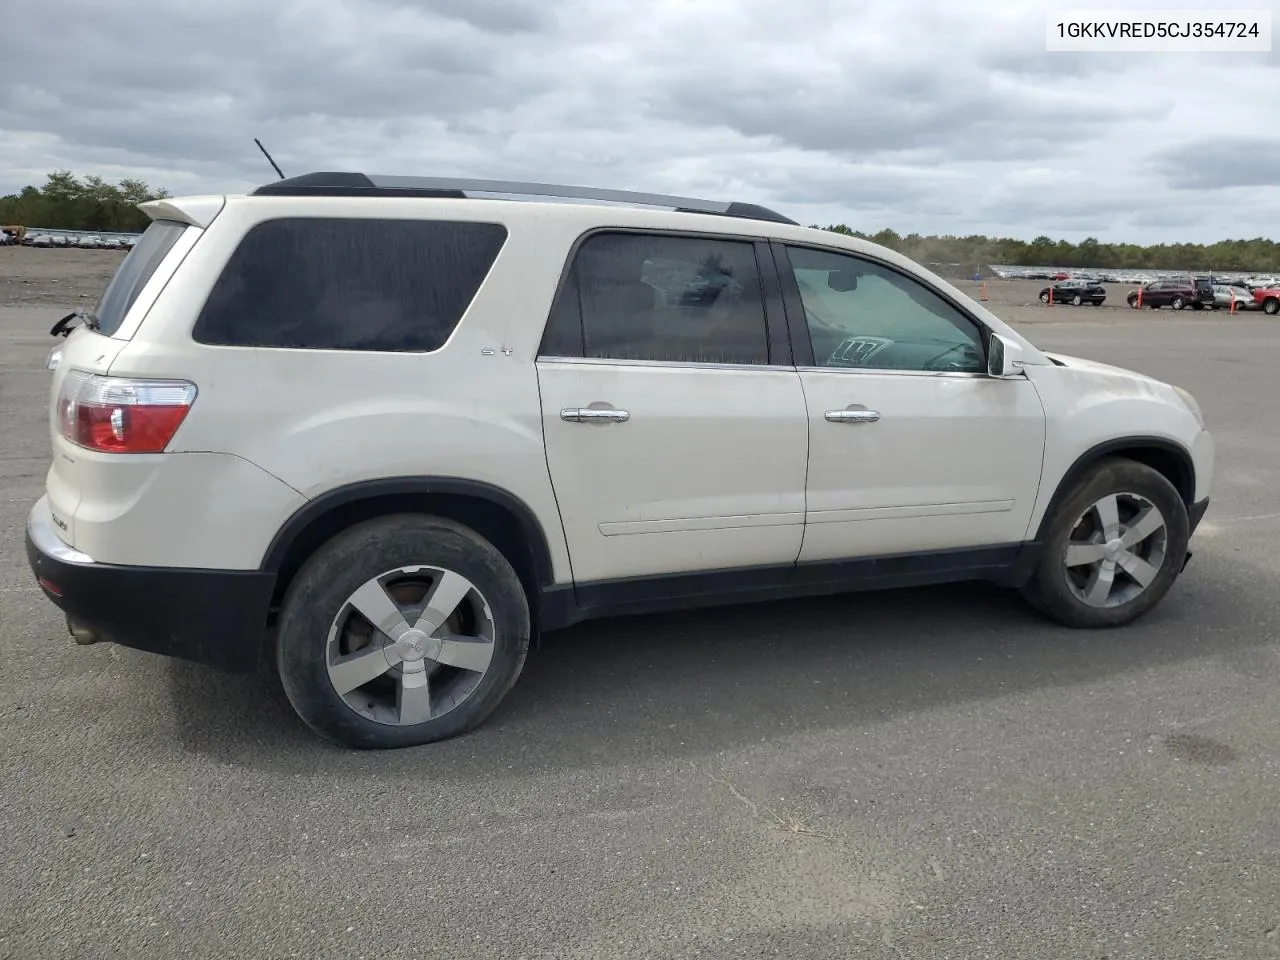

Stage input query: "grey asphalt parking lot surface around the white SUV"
[{"left": 0, "top": 250, "right": 1280, "bottom": 960}]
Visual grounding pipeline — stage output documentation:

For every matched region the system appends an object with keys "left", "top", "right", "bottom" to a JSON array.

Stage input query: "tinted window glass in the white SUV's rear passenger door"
[{"left": 541, "top": 233, "right": 769, "bottom": 365}]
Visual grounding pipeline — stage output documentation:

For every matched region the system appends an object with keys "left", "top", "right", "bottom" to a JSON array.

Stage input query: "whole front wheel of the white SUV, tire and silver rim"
[{"left": 1023, "top": 458, "right": 1190, "bottom": 628}]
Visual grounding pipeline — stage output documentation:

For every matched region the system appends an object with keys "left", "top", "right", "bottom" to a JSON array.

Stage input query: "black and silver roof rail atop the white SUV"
[{"left": 252, "top": 173, "right": 799, "bottom": 225}]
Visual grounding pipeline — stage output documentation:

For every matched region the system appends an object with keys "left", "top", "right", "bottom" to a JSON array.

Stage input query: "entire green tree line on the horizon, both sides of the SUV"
[{"left": 0, "top": 170, "right": 1280, "bottom": 273}]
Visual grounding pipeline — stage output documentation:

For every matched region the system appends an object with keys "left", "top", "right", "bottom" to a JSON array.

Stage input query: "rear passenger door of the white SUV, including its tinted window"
[{"left": 538, "top": 232, "right": 808, "bottom": 586}]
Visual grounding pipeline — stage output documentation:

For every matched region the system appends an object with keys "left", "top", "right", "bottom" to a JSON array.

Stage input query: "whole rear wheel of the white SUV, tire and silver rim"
[{"left": 276, "top": 515, "right": 530, "bottom": 748}]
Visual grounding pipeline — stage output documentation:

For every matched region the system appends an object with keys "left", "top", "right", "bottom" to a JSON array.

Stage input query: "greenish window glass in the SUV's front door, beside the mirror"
[{"left": 788, "top": 247, "right": 986, "bottom": 372}]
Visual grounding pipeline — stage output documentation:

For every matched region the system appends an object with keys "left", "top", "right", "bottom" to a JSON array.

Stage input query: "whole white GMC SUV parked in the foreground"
[{"left": 27, "top": 174, "right": 1213, "bottom": 746}]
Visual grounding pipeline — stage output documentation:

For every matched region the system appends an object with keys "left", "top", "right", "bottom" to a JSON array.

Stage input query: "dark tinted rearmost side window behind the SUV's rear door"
[{"left": 192, "top": 218, "right": 507, "bottom": 353}]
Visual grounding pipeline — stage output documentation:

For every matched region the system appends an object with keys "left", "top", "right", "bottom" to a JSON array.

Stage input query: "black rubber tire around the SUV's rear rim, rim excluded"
[{"left": 276, "top": 513, "right": 530, "bottom": 749}]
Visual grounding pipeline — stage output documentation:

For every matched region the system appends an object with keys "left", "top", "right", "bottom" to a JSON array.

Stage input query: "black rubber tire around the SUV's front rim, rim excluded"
[{"left": 1021, "top": 457, "right": 1190, "bottom": 630}]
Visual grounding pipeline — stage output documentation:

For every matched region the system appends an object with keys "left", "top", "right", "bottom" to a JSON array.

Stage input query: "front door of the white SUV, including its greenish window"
[{"left": 778, "top": 241, "right": 1044, "bottom": 562}]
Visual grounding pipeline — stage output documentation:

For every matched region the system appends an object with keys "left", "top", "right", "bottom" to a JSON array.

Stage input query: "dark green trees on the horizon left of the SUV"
[{"left": 0, "top": 170, "right": 169, "bottom": 233}]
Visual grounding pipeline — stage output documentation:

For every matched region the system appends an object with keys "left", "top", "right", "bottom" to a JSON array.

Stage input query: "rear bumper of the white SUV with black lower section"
[{"left": 27, "top": 497, "right": 275, "bottom": 672}]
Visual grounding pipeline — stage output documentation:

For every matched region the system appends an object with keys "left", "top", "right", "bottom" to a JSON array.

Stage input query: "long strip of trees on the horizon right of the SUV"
[{"left": 823, "top": 224, "right": 1280, "bottom": 273}]
